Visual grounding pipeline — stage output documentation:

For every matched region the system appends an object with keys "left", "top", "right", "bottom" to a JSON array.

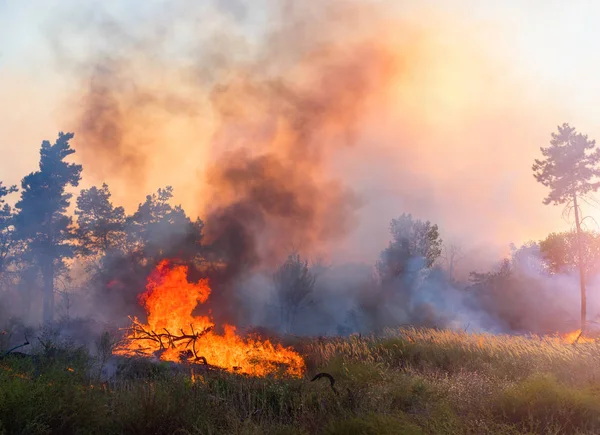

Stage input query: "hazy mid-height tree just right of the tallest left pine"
[{"left": 75, "top": 184, "right": 126, "bottom": 257}]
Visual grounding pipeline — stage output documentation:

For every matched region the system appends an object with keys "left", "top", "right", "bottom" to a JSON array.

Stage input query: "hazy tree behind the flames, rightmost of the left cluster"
[{"left": 127, "top": 186, "right": 204, "bottom": 261}]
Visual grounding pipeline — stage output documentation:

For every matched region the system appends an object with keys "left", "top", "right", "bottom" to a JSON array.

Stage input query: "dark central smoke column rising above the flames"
[{"left": 199, "top": 41, "right": 389, "bottom": 269}]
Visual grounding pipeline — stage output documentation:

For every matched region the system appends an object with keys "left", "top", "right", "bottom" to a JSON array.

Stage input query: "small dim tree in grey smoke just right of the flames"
[{"left": 273, "top": 252, "right": 316, "bottom": 332}]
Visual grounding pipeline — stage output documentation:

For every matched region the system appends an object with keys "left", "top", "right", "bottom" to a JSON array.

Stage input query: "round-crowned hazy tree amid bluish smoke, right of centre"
[{"left": 376, "top": 214, "right": 442, "bottom": 281}]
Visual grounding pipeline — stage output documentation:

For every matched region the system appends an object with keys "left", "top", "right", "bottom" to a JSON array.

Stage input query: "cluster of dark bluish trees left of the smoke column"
[{"left": 0, "top": 132, "right": 203, "bottom": 322}]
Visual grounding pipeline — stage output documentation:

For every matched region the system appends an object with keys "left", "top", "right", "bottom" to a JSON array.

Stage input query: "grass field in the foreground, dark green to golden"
[{"left": 0, "top": 329, "right": 600, "bottom": 435}]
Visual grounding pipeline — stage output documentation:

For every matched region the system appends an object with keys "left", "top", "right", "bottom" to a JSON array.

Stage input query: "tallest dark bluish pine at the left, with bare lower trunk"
[{"left": 15, "top": 132, "right": 82, "bottom": 322}]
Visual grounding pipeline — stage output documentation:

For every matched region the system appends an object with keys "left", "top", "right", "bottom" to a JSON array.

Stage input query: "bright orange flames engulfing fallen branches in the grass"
[{"left": 115, "top": 261, "right": 305, "bottom": 377}]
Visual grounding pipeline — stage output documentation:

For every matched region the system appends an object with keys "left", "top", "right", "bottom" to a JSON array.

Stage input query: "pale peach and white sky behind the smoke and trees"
[{"left": 0, "top": 0, "right": 600, "bottom": 270}]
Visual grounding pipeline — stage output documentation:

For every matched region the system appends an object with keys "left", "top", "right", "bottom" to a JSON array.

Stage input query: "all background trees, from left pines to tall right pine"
[{"left": 0, "top": 124, "right": 600, "bottom": 332}]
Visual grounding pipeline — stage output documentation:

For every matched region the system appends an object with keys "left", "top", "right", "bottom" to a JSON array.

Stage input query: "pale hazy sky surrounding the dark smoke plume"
[{"left": 0, "top": 0, "right": 600, "bottom": 266}]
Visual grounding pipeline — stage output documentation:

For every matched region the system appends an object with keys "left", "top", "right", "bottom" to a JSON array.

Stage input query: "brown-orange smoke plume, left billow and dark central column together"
[{"left": 62, "top": 2, "right": 398, "bottom": 276}]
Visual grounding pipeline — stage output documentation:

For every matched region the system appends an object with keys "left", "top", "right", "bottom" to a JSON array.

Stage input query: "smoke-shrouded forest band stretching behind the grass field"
[{"left": 0, "top": 124, "right": 600, "bottom": 335}]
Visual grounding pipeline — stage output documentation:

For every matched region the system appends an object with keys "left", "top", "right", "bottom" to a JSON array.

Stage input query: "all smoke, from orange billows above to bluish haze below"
[{"left": 0, "top": 0, "right": 593, "bottom": 333}]
